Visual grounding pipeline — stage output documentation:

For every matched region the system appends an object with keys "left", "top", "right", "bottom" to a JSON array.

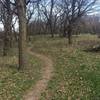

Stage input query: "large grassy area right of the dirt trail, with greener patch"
[{"left": 32, "top": 35, "right": 100, "bottom": 100}]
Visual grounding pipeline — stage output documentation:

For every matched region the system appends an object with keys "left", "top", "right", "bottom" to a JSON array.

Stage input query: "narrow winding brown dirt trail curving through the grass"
[{"left": 24, "top": 48, "right": 53, "bottom": 100}]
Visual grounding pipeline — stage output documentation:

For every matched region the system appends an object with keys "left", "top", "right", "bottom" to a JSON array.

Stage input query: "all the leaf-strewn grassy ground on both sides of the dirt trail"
[{"left": 0, "top": 35, "right": 100, "bottom": 100}]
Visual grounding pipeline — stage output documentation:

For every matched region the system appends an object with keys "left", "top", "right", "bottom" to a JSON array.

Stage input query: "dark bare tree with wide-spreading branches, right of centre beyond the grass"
[{"left": 61, "top": 0, "right": 96, "bottom": 44}]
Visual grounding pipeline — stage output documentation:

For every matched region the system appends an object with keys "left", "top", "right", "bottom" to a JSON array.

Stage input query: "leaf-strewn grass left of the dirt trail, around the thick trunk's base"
[{"left": 0, "top": 49, "right": 42, "bottom": 100}]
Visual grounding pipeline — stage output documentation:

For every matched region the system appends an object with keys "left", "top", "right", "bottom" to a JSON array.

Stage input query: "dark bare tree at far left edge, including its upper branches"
[{"left": 0, "top": 0, "right": 13, "bottom": 56}]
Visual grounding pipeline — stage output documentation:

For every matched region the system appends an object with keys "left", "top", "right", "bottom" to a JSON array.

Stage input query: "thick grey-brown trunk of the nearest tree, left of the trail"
[{"left": 16, "top": 0, "right": 27, "bottom": 70}]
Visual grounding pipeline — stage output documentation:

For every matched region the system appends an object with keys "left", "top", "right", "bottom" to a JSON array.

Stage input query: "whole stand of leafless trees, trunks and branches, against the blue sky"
[{"left": 0, "top": 0, "right": 100, "bottom": 66}]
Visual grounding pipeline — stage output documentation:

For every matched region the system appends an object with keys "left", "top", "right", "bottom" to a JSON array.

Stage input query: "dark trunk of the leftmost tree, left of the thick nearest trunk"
[{"left": 3, "top": 0, "right": 13, "bottom": 56}]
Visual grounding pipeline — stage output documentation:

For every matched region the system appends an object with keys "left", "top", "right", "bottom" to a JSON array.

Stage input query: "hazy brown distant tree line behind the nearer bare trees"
[{"left": 28, "top": 15, "right": 100, "bottom": 37}]
